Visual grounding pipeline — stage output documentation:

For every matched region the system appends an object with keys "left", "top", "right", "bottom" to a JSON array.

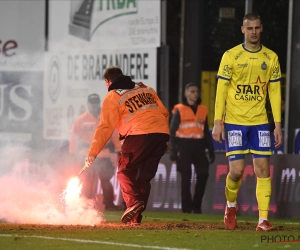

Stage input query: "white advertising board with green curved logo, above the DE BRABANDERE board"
[{"left": 49, "top": 0, "right": 161, "bottom": 51}]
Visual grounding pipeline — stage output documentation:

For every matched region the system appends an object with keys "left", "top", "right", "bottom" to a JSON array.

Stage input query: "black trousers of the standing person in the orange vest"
[{"left": 176, "top": 148, "right": 209, "bottom": 213}]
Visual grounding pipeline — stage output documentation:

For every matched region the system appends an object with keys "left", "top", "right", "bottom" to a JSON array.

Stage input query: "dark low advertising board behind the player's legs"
[{"left": 147, "top": 152, "right": 300, "bottom": 218}]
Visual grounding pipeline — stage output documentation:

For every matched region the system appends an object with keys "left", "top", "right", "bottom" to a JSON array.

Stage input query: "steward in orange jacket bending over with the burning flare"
[{"left": 85, "top": 66, "right": 170, "bottom": 225}]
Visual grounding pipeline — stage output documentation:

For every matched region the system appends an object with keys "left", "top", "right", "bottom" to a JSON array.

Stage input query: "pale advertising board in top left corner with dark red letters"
[{"left": 0, "top": 0, "right": 45, "bottom": 71}]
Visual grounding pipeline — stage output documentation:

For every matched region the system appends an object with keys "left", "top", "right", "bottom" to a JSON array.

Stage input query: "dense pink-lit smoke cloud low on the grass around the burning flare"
[{"left": 0, "top": 145, "right": 103, "bottom": 225}]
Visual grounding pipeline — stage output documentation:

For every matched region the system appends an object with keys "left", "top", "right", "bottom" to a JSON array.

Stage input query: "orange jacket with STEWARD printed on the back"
[{"left": 89, "top": 83, "right": 170, "bottom": 156}]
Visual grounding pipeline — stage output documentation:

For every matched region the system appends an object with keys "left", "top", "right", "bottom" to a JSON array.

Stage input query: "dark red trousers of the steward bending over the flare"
[{"left": 117, "top": 133, "right": 170, "bottom": 207}]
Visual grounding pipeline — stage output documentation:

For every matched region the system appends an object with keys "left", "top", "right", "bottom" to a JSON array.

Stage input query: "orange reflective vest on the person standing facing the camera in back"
[{"left": 172, "top": 104, "right": 208, "bottom": 139}]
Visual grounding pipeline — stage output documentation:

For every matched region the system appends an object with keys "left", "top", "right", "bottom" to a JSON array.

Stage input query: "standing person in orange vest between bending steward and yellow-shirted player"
[{"left": 170, "top": 83, "right": 215, "bottom": 214}]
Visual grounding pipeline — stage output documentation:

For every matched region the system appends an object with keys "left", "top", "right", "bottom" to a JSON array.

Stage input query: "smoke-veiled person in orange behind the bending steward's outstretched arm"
[{"left": 69, "top": 93, "right": 123, "bottom": 210}]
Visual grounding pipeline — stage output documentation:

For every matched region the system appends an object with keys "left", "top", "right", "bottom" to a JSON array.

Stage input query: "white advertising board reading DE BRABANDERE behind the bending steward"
[{"left": 44, "top": 48, "right": 157, "bottom": 140}]
